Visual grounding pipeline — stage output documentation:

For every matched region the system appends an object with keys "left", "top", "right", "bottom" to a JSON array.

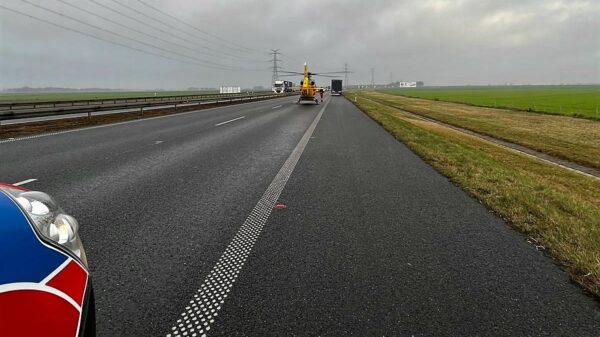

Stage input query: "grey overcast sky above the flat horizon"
[{"left": 0, "top": 0, "right": 600, "bottom": 89}]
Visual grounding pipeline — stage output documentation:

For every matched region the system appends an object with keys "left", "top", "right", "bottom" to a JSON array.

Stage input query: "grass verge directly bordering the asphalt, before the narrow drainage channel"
[{"left": 346, "top": 93, "right": 600, "bottom": 296}]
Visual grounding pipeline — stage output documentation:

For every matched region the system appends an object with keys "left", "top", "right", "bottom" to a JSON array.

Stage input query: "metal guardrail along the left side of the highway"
[{"left": 0, "top": 92, "right": 286, "bottom": 121}]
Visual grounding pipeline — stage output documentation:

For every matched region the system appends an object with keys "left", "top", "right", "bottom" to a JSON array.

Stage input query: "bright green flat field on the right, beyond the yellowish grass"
[{"left": 382, "top": 85, "right": 600, "bottom": 119}]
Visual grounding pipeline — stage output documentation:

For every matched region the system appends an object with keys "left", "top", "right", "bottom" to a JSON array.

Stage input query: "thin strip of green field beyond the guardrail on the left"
[{"left": 0, "top": 91, "right": 218, "bottom": 102}]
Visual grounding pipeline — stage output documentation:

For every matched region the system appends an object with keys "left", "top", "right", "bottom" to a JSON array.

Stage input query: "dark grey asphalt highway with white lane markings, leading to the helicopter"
[{"left": 0, "top": 93, "right": 600, "bottom": 336}]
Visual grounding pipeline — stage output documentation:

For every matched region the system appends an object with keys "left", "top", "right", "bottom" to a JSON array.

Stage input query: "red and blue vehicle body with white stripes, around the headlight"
[{"left": 0, "top": 185, "right": 95, "bottom": 337}]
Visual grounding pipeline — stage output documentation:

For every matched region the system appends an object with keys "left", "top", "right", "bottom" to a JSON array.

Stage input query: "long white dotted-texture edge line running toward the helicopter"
[{"left": 167, "top": 98, "right": 329, "bottom": 337}]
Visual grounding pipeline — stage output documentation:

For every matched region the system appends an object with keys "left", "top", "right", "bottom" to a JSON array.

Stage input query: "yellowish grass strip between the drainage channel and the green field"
[{"left": 361, "top": 92, "right": 600, "bottom": 169}]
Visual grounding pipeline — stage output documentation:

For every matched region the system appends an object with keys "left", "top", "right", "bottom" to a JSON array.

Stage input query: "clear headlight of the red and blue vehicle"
[{"left": 5, "top": 189, "right": 87, "bottom": 267}]
